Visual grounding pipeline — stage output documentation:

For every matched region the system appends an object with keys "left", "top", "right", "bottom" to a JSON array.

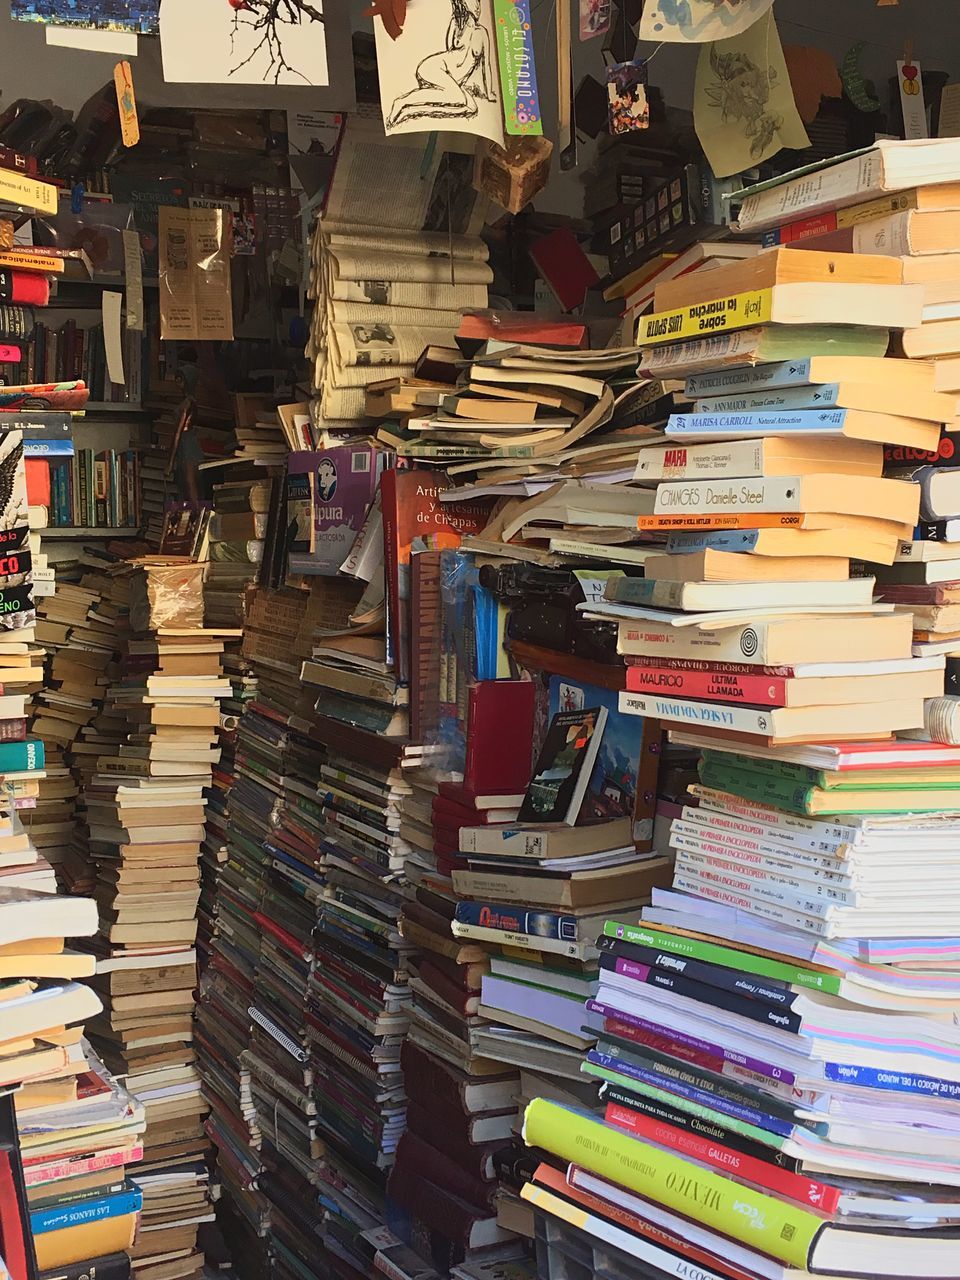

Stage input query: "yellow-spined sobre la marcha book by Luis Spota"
[{"left": 636, "top": 283, "right": 923, "bottom": 347}]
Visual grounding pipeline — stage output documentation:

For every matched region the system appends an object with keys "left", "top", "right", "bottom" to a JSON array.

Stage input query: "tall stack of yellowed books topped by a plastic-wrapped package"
[{"left": 77, "top": 559, "right": 230, "bottom": 1277}]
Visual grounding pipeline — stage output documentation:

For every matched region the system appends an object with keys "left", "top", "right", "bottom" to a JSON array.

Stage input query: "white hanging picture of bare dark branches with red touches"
[{"left": 160, "top": 0, "right": 330, "bottom": 87}]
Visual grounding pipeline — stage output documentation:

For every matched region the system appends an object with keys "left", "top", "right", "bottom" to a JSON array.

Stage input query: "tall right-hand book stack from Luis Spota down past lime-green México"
[{"left": 522, "top": 157, "right": 960, "bottom": 1280}]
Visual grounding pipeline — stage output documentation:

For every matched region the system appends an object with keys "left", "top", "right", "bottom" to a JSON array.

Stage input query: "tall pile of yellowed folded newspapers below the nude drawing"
[{"left": 307, "top": 116, "right": 493, "bottom": 435}]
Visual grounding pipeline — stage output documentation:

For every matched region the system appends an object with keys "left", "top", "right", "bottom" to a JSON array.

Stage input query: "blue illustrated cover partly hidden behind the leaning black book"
[{"left": 547, "top": 676, "right": 643, "bottom": 824}]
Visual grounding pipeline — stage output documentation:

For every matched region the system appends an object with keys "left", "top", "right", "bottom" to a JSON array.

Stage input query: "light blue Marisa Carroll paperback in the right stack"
[{"left": 666, "top": 408, "right": 940, "bottom": 449}]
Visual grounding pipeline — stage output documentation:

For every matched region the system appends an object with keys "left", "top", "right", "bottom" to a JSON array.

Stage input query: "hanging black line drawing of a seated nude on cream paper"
[{"left": 376, "top": 0, "right": 512, "bottom": 146}]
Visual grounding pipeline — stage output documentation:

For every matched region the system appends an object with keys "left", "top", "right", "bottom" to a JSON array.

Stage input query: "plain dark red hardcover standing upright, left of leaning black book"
[{"left": 463, "top": 680, "right": 534, "bottom": 796}]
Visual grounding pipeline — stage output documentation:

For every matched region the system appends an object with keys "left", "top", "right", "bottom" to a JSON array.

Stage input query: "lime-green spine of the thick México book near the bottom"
[{"left": 524, "top": 1098, "right": 822, "bottom": 1270}]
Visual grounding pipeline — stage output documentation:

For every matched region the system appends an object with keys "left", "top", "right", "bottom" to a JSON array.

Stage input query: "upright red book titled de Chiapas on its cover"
[{"left": 380, "top": 470, "right": 492, "bottom": 684}]
